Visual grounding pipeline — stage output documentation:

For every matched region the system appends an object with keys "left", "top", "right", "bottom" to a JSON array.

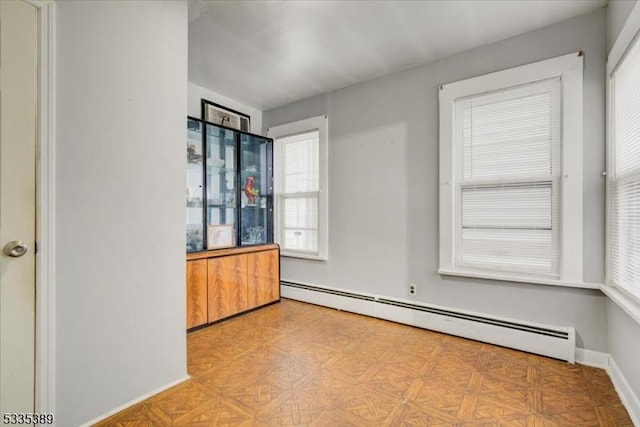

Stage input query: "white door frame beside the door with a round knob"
[{"left": 22, "top": 0, "right": 56, "bottom": 414}]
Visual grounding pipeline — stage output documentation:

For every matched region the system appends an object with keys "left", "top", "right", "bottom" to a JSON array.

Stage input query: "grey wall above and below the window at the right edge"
[{"left": 607, "top": 0, "right": 640, "bottom": 419}]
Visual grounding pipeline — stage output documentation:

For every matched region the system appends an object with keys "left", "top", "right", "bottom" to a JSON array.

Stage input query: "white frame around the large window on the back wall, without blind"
[{"left": 438, "top": 52, "right": 584, "bottom": 288}]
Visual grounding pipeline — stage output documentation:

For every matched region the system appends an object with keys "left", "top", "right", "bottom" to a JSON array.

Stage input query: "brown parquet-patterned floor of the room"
[{"left": 98, "top": 300, "right": 632, "bottom": 427}]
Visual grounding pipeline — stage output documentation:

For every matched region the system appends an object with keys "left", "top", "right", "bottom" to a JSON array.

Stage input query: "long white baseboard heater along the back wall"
[{"left": 280, "top": 281, "right": 576, "bottom": 363}]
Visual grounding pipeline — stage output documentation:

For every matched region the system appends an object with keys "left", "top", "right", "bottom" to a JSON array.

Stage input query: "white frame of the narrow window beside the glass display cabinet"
[{"left": 267, "top": 116, "right": 329, "bottom": 261}]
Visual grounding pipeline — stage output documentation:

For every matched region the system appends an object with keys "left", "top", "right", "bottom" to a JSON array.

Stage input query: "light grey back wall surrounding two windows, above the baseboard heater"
[{"left": 263, "top": 10, "right": 608, "bottom": 352}]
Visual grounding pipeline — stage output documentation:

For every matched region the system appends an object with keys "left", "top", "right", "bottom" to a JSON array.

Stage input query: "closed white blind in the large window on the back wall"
[{"left": 454, "top": 78, "right": 561, "bottom": 277}]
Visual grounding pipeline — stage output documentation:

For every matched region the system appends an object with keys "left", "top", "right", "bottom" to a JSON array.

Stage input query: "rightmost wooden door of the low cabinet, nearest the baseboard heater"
[{"left": 248, "top": 250, "right": 280, "bottom": 308}]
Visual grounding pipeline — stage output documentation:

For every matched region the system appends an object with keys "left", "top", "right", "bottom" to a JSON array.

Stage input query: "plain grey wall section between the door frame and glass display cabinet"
[{"left": 56, "top": 0, "right": 188, "bottom": 426}]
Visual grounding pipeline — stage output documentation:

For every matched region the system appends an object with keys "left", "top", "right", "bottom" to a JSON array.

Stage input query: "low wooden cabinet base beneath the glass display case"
[{"left": 182, "top": 244, "right": 280, "bottom": 329}]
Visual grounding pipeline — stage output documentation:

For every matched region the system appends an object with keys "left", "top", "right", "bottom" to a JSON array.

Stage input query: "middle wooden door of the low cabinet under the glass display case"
[{"left": 208, "top": 254, "right": 248, "bottom": 322}]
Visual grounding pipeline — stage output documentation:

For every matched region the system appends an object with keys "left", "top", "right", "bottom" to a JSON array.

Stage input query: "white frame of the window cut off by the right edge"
[{"left": 602, "top": 3, "right": 640, "bottom": 308}]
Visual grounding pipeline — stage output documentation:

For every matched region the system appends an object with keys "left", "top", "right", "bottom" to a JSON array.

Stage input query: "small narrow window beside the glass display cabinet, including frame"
[{"left": 268, "top": 116, "right": 327, "bottom": 259}]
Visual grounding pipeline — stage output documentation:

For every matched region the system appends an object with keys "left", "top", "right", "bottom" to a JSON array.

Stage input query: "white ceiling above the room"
[{"left": 189, "top": 0, "right": 607, "bottom": 110}]
